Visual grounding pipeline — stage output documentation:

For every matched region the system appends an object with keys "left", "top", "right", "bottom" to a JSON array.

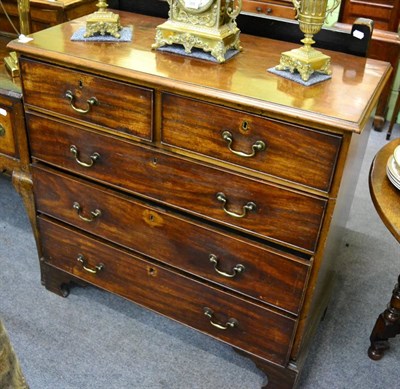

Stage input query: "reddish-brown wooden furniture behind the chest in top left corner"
[{"left": 0, "top": 0, "right": 98, "bottom": 34}]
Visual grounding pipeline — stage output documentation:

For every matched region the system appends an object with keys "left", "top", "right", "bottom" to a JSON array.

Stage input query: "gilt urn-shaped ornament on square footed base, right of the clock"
[{"left": 276, "top": 0, "right": 339, "bottom": 81}]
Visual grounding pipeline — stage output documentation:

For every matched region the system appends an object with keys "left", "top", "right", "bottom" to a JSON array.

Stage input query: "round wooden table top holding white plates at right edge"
[{"left": 369, "top": 138, "right": 400, "bottom": 242}]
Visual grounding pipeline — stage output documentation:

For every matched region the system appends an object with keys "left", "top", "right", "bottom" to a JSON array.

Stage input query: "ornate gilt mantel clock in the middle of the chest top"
[{"left": 153, "top": 0, "right": 242, "bottom": 62}]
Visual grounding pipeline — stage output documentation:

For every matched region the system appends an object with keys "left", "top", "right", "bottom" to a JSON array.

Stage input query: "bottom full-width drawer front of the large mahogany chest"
[{"left": 39, "top": 218, "right": 295, "bottom": 365}]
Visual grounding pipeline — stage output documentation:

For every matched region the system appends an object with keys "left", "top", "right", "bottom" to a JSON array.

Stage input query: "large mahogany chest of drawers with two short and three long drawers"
[{"left": 10, "top": 12, "right": 390, "bottom": 388}]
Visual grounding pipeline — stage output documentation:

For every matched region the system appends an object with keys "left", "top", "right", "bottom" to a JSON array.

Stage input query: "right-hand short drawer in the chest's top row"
[{"left": 162, "top": 94, "right": 341, "bottom": 192}]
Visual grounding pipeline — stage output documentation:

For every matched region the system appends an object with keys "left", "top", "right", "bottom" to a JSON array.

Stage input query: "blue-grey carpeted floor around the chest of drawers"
[{"left": 0, "top": 127, "right": 400, "bottom": 389}]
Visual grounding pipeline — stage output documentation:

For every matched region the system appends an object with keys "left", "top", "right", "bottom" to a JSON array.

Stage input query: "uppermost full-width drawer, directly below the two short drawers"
[{"left": 27, "top": 115, "right": 326, "bottom": 252}]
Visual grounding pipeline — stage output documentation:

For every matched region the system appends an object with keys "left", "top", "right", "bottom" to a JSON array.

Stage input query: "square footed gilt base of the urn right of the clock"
[{"left": 276, "top": 47, "right": 332, "bottom": 81}]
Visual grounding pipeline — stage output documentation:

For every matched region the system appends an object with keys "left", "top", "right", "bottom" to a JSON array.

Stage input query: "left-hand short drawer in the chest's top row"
[{"left": 20, "top": 59, "right": 153, "bottom": 141}]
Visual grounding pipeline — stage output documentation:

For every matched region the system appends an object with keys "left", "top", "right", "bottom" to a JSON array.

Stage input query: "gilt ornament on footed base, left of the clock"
[{"left": 84, "top": 0, "right": 121, "bottom": 38}]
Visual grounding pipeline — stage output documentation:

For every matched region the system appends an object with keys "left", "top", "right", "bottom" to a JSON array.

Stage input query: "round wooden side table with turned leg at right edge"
[{"left": 368, "top": 139, "right": 400, "bottom": 360}]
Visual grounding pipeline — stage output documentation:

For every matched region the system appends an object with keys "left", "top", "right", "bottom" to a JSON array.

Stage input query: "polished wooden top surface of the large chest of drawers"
[{"left": 9, "top": 12, "right": 391, "bottom": 132}]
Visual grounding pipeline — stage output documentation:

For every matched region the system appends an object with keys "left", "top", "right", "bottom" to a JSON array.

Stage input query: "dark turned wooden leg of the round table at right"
[{"left": 368, "top": 275, "right": 400, "bottom": 361}]
